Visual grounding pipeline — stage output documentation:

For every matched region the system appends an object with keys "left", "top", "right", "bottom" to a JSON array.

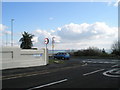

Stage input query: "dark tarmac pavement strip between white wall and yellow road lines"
[{"left": 2, "top": 60, "right": 85, "bottom": 77}]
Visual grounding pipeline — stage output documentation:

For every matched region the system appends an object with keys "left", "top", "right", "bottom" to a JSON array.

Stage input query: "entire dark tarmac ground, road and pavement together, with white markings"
[{"left": 1, "top": 58, "right": 120, "bottom": 90}]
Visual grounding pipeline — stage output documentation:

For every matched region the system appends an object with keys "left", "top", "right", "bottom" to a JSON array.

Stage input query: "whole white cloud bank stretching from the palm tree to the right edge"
[{"left": 33, "top": 22, "right": 118, "bottom": 49}]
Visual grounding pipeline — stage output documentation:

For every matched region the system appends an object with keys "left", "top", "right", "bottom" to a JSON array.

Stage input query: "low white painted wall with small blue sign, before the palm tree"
[{"left": 0, "top": 47, "right": 48, "bottom": 70}]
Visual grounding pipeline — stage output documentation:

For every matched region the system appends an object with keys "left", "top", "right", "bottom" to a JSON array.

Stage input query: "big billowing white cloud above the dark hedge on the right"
[{"left": 56, "top": 22, "right": 118, "bottom": 48}]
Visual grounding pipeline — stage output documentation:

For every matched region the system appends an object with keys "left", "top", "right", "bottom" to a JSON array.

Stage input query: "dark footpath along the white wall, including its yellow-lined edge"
[{"left": 0, "top": 60, "right": 84, "bottom": 80}]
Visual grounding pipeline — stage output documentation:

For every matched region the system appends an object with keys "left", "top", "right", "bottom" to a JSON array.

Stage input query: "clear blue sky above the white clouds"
[{"left": 3, "top": 2, "right": 118, "bottom": 31}]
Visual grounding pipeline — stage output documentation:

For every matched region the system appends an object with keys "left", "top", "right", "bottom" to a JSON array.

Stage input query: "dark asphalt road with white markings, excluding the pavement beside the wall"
[{"left": 2, "top": 59, "right": 120, "bottom": 90}]
